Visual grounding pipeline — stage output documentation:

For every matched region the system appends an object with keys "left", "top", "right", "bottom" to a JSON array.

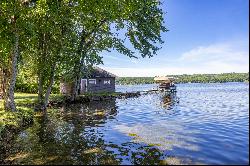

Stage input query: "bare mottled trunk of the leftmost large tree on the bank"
[{"left": 4, "top": 33, "right": 19, "bottom": 111}]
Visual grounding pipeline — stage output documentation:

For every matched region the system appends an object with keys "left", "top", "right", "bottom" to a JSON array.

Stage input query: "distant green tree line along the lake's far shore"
[{"left": 116, "top": 73, "right": 249, "bottom": 85}]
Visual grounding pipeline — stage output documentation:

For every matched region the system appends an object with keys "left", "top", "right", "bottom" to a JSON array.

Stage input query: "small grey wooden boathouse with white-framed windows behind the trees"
[{"left": 60, "top": 67, "right": 117, "bottom": 94}]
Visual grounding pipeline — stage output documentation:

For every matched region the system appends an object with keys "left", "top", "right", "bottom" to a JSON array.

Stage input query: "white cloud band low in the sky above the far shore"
[{"left": 101, "top": 42, "right": 249, "bottom": 77}]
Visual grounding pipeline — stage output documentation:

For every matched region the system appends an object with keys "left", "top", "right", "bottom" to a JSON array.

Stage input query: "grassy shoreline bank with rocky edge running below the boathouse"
[{"left": 0, "top": 92, "right": 140, "bottom": 136}]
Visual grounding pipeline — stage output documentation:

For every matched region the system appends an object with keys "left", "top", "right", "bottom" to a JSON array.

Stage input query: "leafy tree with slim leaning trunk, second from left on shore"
[{"left": 25, "top": 0, "right": 74, "bottom": 110}]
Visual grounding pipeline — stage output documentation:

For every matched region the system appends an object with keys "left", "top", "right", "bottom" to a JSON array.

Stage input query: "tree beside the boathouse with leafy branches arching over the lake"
[{"left": 69, "top": 0, "right": 167, "bottom": 100}]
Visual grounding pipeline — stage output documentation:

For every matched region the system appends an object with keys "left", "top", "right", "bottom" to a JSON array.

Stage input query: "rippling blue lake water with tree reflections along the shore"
[{"left": 0, "top": 83, "right": 249, "bottom": 164}]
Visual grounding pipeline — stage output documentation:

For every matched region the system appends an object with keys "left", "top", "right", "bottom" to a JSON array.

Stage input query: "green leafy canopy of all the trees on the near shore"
[{"left": 0, "top": 0, "right": 167, "bottom": 104}]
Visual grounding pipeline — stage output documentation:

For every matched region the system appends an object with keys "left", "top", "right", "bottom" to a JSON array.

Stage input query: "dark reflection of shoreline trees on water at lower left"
[{"left": 3, "top": 100, "right": 170, "bottom": 165}]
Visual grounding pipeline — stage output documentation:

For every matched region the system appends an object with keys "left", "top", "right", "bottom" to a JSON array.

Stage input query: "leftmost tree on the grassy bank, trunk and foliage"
[{"left": 0, "top": 0, "right": 29, "bottom": 111}]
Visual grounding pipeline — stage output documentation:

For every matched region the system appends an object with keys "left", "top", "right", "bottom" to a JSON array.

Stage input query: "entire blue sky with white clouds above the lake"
[{"left": 99, "top": 0, "right": 249, "bottom": 77}]
